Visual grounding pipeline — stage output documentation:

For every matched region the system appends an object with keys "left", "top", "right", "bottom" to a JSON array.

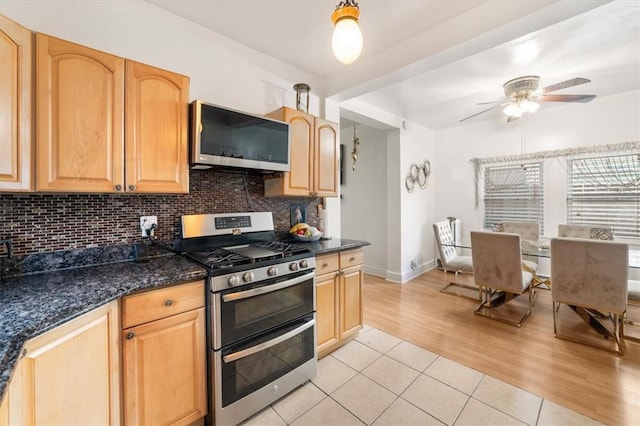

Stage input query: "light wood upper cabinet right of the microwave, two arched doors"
[{"left": 264, "top": 107, "right": 339, "bottom": 197}]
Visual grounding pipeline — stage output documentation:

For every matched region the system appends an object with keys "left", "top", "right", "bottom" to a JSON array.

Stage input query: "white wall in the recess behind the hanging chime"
[{"left": 340, "top": 124, "right": 387, "bottom": 277}]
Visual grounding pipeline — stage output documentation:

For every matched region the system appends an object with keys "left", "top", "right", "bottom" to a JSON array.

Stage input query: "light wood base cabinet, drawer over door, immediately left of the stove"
[{"left": 122, "top": 281, "right": 207, "bottom": 425}]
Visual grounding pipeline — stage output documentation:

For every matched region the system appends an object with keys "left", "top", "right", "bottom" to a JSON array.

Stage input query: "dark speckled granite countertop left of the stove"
[{"left": 0, "top": 251, "right": 206, "bottom": 401}]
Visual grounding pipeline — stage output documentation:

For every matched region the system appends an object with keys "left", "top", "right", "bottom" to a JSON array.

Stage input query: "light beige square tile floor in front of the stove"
[{"left": 243, "top": 326, "right": 600, "bottom": 426}]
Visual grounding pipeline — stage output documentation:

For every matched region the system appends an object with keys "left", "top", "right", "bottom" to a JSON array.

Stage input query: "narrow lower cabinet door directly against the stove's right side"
[{"left": 316, "top": 272, "right": 340, "bottom": 357}]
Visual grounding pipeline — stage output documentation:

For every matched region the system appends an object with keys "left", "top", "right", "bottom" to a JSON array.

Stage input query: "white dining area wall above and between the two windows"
[{"left": 433, "top": 91, "right": 640, "bottom": 237}]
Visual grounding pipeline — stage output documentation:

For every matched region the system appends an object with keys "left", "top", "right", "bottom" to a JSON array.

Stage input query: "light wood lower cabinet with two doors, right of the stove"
[{"left": 316, "top": 249, "right": 364, "bottom": 358}]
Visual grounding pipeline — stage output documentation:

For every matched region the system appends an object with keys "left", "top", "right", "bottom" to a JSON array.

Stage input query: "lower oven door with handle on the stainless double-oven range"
[{"left": 216, "top": 316, "right": 315, "bottom": 407}]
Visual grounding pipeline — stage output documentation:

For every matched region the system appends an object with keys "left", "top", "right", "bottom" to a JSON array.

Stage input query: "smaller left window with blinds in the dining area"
[{"left": 484, "top": 162, "right": 544, "bottom": 232}]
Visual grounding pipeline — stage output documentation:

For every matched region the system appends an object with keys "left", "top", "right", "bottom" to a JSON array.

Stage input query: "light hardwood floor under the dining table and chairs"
[{"left": 364, "top": 270, "right": 640, "bottom": 425}]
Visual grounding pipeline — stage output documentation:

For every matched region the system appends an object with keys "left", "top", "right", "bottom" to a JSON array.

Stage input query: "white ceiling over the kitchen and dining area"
[{"left": 148, "top": 0, "right": 640, "bottom": 129}]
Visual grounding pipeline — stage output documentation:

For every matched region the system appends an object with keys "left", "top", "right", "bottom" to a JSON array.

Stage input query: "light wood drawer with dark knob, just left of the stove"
[{"left": 122, "top": 281, "right": 204, "bottom": 328}]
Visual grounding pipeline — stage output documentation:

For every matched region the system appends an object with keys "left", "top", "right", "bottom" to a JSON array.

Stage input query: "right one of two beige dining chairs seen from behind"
[{"left": 551, "top": 238, "right": 629, "bottom": 355}]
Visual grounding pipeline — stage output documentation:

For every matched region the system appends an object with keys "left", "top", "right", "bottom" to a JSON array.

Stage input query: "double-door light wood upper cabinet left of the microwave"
[{"left": 36, "top": 33, "right": 189, "bottom": 193}]
